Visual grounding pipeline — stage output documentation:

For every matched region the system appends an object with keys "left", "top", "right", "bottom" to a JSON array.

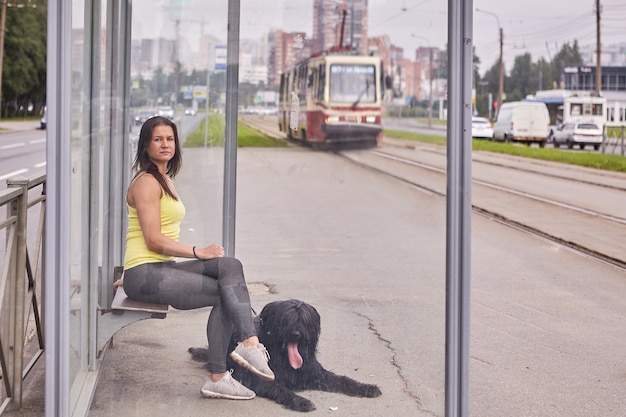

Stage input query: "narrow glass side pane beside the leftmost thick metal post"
[{"left": 69, "top": 0, "right": 111, "bottom": 405}]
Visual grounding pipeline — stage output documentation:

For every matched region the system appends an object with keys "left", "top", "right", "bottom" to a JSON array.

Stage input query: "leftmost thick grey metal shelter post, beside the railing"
[{"left": 45, "top": 0, "right": 72, "bottom": 417}]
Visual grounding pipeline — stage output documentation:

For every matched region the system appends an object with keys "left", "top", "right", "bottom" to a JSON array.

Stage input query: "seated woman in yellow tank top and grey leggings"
[{"left": 116, "top": 116, "right": 274, "bottom": 399}]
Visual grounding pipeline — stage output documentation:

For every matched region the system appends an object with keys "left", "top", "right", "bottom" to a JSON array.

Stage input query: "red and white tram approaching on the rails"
[{"left": 278, "top": 50, "right": 383, "bottom": 147}]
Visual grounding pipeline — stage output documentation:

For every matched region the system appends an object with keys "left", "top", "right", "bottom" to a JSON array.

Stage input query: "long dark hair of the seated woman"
[{"left": 133, "top": 116, "right": 183, "bottom": 200}]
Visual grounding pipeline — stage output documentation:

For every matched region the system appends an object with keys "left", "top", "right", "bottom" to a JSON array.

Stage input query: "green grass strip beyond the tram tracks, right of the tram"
[{"left": 385, "top": 129, "right": 626, "bottom": 172}]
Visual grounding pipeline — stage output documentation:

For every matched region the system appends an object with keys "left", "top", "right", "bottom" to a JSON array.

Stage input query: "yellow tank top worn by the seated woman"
[{"left": 124, "top": 191, "right": 185, "bottom": 270}]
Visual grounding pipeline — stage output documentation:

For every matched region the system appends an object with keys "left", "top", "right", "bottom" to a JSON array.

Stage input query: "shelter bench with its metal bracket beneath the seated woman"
[{"left": 98, "top": 266, "right": 170, "bottom": 353}]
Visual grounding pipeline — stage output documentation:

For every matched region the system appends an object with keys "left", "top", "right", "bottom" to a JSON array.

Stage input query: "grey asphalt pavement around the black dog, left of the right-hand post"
[{"left": 7, "top": 147, "right": 445, "bottom": 417}]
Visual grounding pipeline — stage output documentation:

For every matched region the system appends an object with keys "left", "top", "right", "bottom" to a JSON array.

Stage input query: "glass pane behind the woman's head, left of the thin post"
[{"left": 130, "top": 0, "right": 227, "bottom": 244}]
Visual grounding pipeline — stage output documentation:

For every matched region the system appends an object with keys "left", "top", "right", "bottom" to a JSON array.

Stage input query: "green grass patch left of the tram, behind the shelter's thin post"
[{"left": 183, "top": 115, "right": 287, "bottom": 148}]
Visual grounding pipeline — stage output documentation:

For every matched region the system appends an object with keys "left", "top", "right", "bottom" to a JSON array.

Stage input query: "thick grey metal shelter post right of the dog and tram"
[{"left": 445, "top": 0, "right": 473, "bottom": 417}]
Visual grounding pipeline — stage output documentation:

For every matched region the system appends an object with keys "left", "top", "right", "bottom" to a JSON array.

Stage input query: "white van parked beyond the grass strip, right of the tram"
[{"left": 493, "top": 101, "right": 550, "bottom": 148}]
